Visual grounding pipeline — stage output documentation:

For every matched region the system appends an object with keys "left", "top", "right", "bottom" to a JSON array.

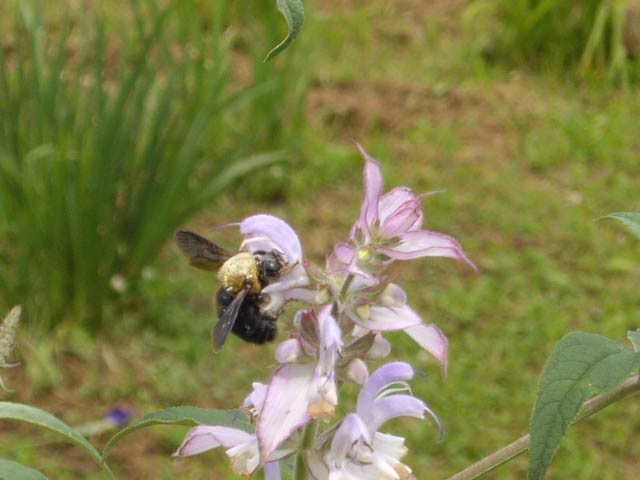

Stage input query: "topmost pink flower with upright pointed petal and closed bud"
[{"left": 350, "top": 145, "right": 477, "bottom": 270}]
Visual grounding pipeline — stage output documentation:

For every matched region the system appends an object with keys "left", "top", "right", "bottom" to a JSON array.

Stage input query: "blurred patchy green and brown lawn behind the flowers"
[{"left": 0, "top": 1, "right": 640, "bottom": 480}]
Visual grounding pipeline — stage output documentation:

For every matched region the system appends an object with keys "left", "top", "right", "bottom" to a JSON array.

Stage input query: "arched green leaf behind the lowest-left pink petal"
[{"left": 102, "top": 407, "right": 253, "bottom": 460}]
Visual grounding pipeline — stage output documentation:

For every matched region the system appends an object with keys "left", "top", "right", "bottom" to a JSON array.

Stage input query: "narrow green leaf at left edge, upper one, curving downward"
[{"left": 0, "top": 402, "right": 113, "bottom": 476}]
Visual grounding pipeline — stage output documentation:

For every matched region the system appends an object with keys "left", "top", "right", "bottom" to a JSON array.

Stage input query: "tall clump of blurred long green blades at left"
[{"left": 0, "top": 0, "right": 308, "bottom": 327}]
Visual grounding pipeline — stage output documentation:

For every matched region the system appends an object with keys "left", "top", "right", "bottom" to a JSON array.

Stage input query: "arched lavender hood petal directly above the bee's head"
[{"left": 240, "top": 215, "right": 302, "bottom": 264}]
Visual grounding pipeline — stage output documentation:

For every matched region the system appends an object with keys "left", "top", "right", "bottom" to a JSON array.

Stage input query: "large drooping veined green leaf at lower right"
[{"left": 529, "top": 332, "right": 640, "bottom": 480}]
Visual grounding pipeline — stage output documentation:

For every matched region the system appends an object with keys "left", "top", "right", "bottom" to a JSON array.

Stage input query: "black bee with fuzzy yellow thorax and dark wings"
[{"left": 176, "top": 231, "right": 287, "bottom": 351}]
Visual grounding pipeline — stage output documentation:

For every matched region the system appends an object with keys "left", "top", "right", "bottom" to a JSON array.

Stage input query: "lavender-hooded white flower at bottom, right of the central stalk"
[{"left": 306, "top": 362, "right": 440, "bottom": 480}]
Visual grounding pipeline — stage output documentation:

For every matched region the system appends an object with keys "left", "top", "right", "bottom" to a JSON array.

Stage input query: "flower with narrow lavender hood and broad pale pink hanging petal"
[{"left": 257, "top": 305, "right": 342, "bottom": 459}]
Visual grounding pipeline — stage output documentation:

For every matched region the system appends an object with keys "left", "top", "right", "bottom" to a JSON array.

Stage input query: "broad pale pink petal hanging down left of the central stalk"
[{"left": 257, "top": 364, "right": 314, "bottom": 460}]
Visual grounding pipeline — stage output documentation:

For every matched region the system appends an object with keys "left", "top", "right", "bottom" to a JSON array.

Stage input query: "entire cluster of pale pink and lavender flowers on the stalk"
[{"left": 175, "top": 147, "right": 475, "bottom": 480}]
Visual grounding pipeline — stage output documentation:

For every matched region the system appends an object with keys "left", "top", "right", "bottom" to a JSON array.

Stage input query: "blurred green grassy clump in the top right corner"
[{"left": 466, "top": 0, "right": 637, "bottom": 83}]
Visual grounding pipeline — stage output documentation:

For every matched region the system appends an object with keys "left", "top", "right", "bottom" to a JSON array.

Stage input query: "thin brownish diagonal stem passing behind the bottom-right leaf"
[{"left": 447, "top": 375, "right": 640, "bottom": 480}]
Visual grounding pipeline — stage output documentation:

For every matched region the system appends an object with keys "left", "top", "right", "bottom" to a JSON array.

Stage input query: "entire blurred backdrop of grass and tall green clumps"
[{"left": 0, "top": 0, "right": 640, "bottom": 480}]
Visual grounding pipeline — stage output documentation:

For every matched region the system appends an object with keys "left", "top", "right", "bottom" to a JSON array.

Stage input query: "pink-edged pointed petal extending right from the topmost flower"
[{"left": 379, "top": 230, "right": 478, "bottom": 271}]
